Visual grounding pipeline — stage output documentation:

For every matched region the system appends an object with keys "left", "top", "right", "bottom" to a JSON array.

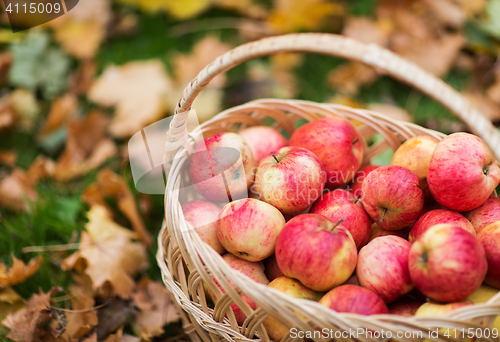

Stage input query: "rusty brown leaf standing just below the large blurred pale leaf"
[{"left": 54, "top": 111, "right": 118, "bottom": 182}]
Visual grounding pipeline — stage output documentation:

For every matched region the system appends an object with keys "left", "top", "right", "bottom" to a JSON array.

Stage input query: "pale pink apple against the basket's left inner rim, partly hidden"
[{"left": 182, "top": 200, "right": 226, "bottom": 254}]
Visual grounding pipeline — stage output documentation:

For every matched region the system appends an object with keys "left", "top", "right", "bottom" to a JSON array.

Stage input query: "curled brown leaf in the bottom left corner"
[{"left": 2, "top": 287, "right": 61, "bottom": 342}]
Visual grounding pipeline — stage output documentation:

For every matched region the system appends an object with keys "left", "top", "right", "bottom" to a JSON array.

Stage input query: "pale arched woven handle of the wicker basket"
[{"left": 167, "top": 33, "right": 500, "bottom": 160}]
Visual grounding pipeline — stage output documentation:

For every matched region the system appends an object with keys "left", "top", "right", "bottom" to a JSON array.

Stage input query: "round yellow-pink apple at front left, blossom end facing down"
[{"left": 217, "top": 198, "right": 285, "bottom": 261}]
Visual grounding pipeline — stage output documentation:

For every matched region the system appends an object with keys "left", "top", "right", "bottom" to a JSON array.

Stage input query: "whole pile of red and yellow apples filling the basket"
[{"left": 182, "top": 117, "right": 500, "bottom": 340}]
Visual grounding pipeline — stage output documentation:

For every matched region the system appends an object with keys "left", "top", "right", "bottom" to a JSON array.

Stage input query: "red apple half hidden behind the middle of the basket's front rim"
[{"left": 319, "top": 285, "right": 389, "bottom": 316}]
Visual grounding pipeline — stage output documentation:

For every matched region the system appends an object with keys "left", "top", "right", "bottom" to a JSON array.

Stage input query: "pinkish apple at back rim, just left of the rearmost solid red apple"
[{"left": 238, "top": 126, "right": 288, "bottom": 165}]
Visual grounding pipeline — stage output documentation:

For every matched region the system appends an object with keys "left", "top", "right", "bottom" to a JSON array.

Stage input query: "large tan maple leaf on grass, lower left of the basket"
[{"left": 61, "top": 205, "right": 148, "bottom": 298}]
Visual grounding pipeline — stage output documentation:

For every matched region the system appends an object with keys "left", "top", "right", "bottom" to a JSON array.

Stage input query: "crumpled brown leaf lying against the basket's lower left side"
[{"left": 132, "top": 279, "right": 179, "bottom": 339}]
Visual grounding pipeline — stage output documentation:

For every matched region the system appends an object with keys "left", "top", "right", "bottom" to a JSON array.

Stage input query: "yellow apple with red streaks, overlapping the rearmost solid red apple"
[{"left": 255, "top": 146, "right": 325, "bottom": 215}]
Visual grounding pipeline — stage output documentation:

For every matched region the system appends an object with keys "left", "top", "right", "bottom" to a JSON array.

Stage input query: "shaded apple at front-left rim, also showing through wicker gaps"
[{"left": 204, "top": 253, "right": 269, "bottom": 325}]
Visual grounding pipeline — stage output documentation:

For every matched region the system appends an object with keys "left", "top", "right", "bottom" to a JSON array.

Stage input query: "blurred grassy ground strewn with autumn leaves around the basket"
[{"left": 0, "top": 0, "right": 500, "bottom": 342}]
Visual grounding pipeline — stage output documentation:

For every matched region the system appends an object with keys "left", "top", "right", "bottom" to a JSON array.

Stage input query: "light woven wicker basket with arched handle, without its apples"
[{"left": 157, "top": 34, "right": 500, "bottom": 341}]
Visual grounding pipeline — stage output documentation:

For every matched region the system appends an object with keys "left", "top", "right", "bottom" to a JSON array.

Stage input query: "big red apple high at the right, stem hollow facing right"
[{"left": 427, "top": 133, "right": 500, "bottom": 211}]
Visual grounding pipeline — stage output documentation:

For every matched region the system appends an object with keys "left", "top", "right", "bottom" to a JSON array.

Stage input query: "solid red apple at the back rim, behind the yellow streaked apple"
[{"left": 290, "top": 117, "right": 363, "bottom": 188}]
